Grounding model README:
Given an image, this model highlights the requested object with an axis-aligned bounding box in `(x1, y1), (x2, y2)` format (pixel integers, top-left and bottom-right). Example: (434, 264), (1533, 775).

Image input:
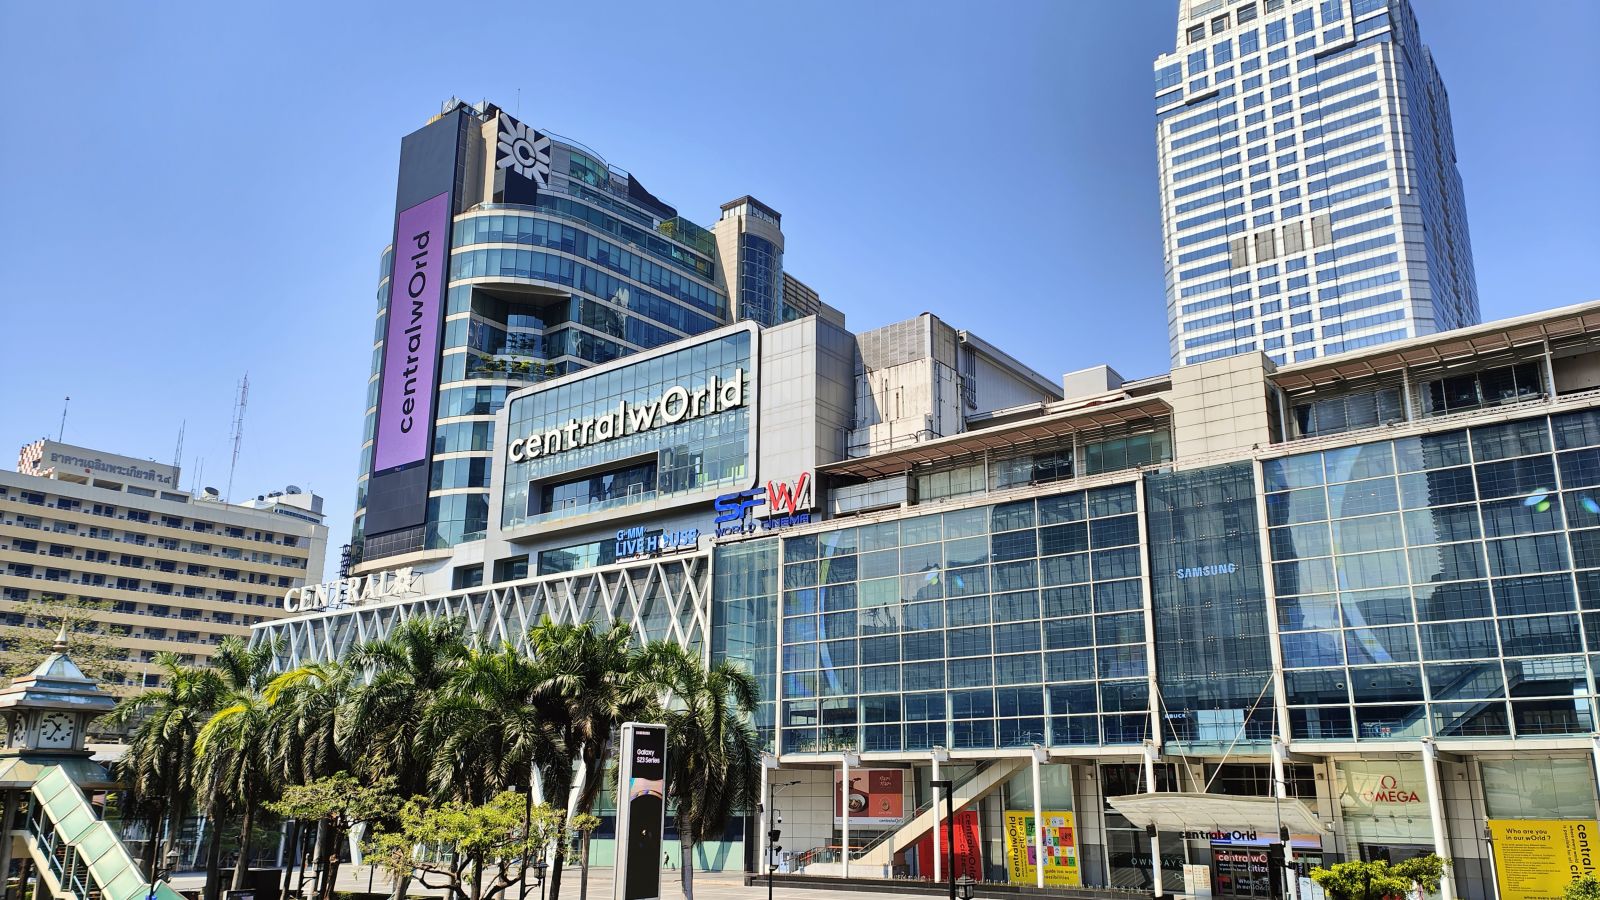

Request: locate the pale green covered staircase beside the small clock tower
(22, 765), (182, 900)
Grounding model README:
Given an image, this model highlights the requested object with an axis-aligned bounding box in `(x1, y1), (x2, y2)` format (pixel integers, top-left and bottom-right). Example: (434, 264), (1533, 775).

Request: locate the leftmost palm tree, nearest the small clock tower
(106, 653), (227, 881)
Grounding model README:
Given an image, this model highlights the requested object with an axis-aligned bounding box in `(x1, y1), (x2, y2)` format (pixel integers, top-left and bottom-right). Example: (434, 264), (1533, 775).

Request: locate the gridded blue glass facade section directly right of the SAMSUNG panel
(1264, 412), (1600, 741)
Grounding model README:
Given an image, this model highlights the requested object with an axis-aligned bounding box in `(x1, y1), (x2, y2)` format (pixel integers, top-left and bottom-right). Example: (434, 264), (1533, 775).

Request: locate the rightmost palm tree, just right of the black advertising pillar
(646, 641), (762, 900)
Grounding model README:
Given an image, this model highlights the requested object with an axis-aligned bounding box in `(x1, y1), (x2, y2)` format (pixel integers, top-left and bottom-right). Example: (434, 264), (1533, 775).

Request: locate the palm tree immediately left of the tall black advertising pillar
(528, 617), (658, 900)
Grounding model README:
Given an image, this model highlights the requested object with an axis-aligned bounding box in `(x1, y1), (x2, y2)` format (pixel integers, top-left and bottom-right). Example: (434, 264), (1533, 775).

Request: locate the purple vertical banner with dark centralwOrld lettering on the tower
(373, 191), (450, 472)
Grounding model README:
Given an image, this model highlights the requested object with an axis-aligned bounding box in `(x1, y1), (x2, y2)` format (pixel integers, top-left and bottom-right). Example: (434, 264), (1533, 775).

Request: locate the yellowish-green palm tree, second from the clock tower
(195, 637), (280, 897)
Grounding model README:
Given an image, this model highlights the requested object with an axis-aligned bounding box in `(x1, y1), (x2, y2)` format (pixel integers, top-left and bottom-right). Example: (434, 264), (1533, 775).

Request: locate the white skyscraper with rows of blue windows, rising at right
(1155, 0), (1478, 365)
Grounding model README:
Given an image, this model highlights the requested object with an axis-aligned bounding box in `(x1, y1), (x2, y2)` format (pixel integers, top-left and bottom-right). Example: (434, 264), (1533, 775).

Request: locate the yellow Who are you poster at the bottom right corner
(1490, 818), (1600, 900)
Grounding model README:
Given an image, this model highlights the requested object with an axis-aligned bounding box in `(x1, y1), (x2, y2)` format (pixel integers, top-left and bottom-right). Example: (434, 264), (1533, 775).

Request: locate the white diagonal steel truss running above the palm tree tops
(250, 552), (712, 669)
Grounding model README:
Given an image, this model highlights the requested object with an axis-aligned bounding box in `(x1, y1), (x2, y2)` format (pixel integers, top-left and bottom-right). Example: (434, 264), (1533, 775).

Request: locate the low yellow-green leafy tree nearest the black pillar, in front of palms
(363, 791), (565, 900)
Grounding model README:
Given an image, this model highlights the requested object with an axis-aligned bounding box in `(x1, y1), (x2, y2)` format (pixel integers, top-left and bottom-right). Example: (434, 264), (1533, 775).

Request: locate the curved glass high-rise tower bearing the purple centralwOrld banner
(352, 99), (816, 572)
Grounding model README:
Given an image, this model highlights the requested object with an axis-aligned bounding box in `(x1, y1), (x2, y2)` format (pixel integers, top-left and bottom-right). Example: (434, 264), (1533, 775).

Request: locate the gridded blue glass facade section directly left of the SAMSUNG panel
(779, 484), (1150, 753)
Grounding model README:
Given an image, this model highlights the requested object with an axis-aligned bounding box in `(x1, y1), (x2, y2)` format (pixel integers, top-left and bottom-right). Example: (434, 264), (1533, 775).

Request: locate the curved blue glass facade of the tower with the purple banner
(352, 126), (731, 560)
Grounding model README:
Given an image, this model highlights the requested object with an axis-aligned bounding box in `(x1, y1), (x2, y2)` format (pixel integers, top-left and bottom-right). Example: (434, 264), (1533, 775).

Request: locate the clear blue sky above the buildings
(0, 0), (1600, 573)
